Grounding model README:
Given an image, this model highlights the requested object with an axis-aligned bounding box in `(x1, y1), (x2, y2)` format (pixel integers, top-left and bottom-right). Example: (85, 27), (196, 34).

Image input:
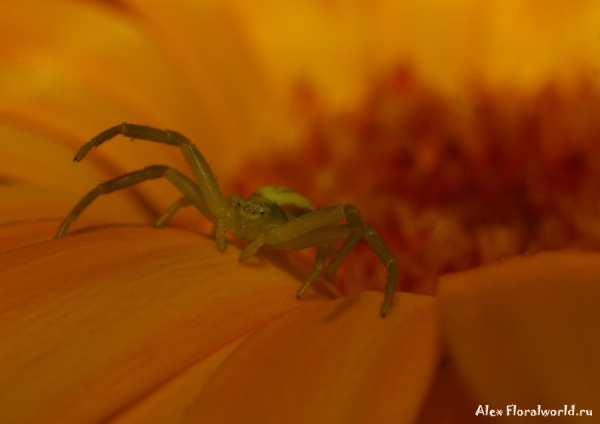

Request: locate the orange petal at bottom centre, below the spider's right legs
(186, 292), (440, 423)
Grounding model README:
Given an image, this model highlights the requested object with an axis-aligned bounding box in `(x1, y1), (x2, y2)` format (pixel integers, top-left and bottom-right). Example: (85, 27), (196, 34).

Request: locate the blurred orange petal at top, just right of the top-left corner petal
(110, 0), (297, 175)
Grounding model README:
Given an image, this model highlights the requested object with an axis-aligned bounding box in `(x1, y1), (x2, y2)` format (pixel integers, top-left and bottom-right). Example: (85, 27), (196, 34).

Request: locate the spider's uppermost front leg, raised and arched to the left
(73, 122), (226, 251)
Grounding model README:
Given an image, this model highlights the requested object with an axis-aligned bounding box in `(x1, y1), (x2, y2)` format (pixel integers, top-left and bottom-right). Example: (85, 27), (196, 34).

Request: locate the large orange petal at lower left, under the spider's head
(0, 227), (332, 423)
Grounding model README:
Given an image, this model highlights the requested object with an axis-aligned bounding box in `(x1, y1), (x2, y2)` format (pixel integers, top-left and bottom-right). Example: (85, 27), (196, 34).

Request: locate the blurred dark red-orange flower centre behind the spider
(230, 69), (600, 294)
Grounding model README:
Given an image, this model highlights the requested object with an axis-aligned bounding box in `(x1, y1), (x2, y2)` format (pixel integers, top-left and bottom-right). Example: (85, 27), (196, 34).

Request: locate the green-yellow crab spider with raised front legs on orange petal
(55, 123), (398, 317)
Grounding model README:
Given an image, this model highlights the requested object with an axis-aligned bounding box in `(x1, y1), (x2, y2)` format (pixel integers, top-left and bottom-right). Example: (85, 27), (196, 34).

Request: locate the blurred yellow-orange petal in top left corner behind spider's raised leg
(0, 0), (222, 209)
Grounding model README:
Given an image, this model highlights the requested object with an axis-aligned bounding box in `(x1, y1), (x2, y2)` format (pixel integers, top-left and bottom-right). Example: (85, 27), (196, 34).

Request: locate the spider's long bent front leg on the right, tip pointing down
(273, 205), (398, 316)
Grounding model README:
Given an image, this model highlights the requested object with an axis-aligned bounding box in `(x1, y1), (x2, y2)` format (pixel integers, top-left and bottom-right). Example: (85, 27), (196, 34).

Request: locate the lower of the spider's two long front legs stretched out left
(55, 165), (215, 238)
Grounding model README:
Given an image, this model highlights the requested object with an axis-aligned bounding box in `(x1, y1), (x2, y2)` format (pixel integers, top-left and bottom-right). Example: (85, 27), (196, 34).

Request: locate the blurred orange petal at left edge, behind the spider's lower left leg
(0, 121), (157, 232)
